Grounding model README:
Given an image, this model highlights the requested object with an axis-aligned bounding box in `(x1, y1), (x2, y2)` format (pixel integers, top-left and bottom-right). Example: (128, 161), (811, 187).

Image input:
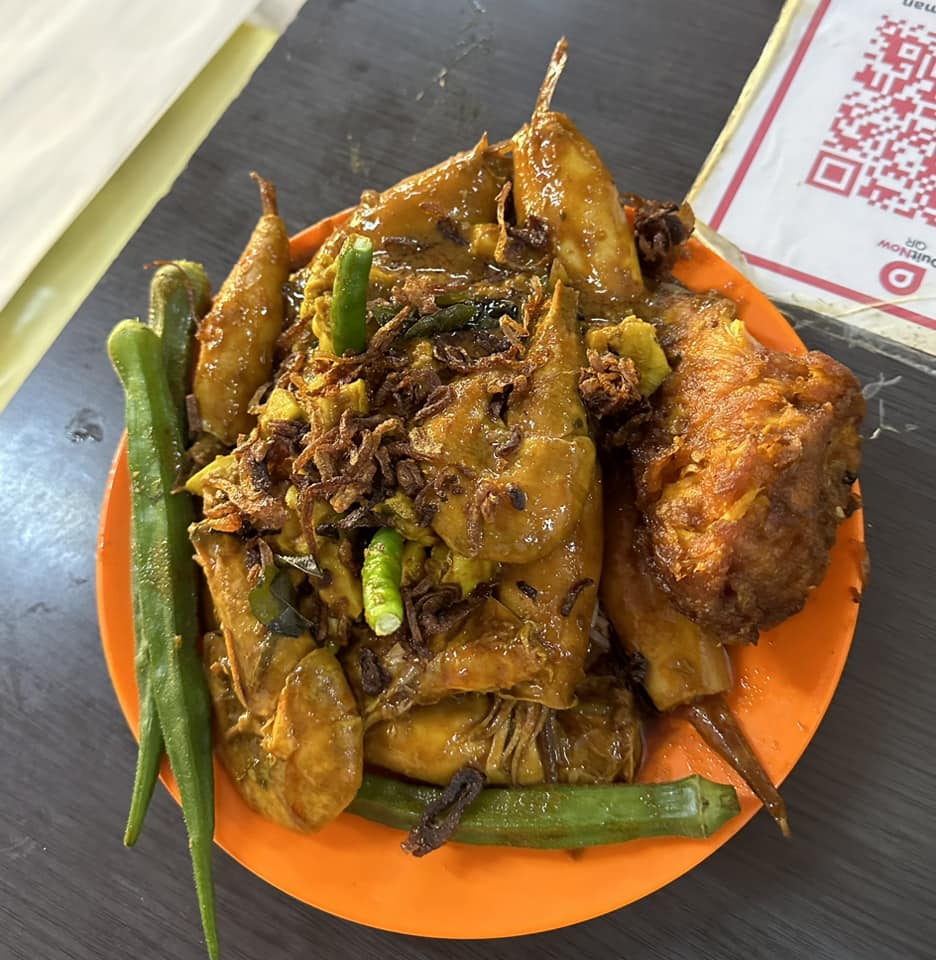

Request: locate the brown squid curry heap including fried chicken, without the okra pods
(179, 44), (863, 839)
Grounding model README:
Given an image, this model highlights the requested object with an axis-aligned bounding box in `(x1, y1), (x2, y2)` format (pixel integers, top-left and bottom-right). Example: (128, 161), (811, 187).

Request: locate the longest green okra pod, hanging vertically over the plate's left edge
(107, 320), (218, 958)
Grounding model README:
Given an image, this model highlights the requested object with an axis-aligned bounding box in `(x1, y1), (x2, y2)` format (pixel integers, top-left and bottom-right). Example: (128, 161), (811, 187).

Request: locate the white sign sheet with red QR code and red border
(690, 0), (936, 353)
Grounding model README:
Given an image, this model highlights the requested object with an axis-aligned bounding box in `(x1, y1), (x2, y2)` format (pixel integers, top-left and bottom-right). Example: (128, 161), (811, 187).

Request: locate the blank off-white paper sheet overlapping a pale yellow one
(0, 0), (256, 308)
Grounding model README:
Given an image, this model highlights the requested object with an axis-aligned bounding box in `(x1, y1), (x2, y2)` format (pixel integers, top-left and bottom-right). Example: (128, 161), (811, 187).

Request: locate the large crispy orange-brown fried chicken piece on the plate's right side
(633, 292), (864, 641)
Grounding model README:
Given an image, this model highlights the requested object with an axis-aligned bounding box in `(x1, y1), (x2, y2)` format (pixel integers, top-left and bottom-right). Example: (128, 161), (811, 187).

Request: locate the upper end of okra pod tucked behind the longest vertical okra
(149, 260), (211, 428)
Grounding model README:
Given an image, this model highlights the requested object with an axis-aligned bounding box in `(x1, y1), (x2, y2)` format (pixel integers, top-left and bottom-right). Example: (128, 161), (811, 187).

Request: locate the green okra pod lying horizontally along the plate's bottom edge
(348, 774), (740, 850)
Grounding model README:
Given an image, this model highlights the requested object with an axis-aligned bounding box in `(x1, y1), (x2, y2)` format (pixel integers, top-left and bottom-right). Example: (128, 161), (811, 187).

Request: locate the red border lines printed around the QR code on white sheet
(711, 0), (936, 330)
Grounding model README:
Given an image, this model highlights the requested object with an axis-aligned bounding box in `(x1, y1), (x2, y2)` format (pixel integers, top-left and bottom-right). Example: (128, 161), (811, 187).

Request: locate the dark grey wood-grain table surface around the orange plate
(0, 0), (936, 960)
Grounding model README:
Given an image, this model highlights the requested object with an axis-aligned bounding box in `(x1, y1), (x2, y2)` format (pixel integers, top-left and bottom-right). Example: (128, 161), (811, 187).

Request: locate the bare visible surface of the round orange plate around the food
(97, 214), (864, 938)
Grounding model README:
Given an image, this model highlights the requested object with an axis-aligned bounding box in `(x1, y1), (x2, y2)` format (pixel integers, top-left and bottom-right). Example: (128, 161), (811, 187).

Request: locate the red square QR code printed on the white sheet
(806, 16), (936, 226)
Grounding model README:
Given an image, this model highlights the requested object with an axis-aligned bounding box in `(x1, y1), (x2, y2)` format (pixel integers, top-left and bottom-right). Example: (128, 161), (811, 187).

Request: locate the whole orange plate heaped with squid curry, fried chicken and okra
(98, 41), (865, 956)
